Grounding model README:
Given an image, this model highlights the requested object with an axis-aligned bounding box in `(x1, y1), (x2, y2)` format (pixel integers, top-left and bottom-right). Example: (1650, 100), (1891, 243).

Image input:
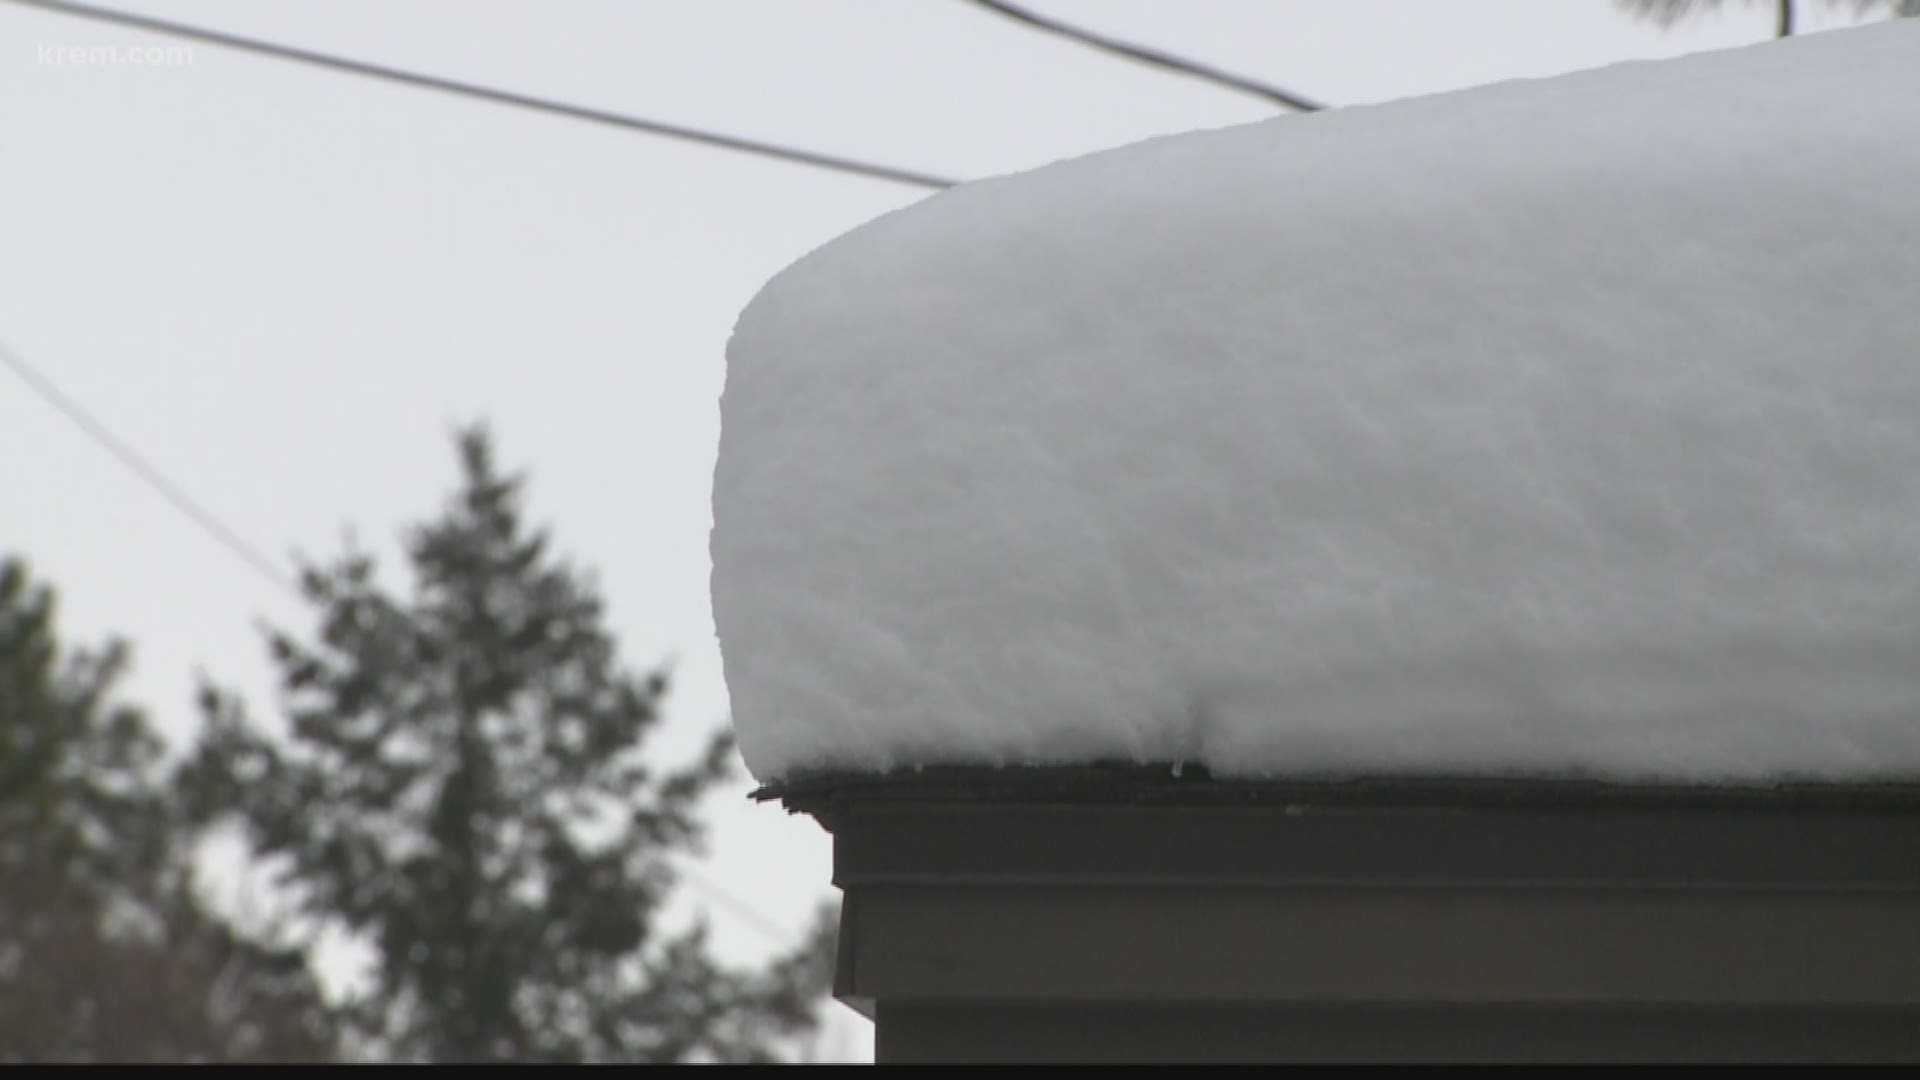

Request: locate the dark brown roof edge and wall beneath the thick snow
(762, 769), (1920, 1063)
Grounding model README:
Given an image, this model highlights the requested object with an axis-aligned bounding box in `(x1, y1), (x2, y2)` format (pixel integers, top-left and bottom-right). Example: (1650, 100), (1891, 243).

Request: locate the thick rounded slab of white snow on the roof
(710, 21), (1920, 782)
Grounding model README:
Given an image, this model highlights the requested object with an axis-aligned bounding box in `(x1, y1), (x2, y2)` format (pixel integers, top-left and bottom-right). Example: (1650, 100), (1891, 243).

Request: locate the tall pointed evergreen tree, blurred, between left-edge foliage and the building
(190, 429), (828, 1063)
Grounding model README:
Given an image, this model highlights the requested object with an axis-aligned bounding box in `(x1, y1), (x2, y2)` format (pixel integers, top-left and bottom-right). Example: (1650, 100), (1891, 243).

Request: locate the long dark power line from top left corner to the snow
(6, 0), (958, 188)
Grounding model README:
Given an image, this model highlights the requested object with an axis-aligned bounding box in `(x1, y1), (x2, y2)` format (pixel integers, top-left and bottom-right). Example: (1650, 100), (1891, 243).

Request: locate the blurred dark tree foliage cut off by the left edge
(0, 559), (332, 1063)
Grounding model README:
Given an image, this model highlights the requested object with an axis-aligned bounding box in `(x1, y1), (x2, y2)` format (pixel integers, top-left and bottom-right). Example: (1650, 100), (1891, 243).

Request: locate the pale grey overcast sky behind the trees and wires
(0, 0), (1889, 1059)
